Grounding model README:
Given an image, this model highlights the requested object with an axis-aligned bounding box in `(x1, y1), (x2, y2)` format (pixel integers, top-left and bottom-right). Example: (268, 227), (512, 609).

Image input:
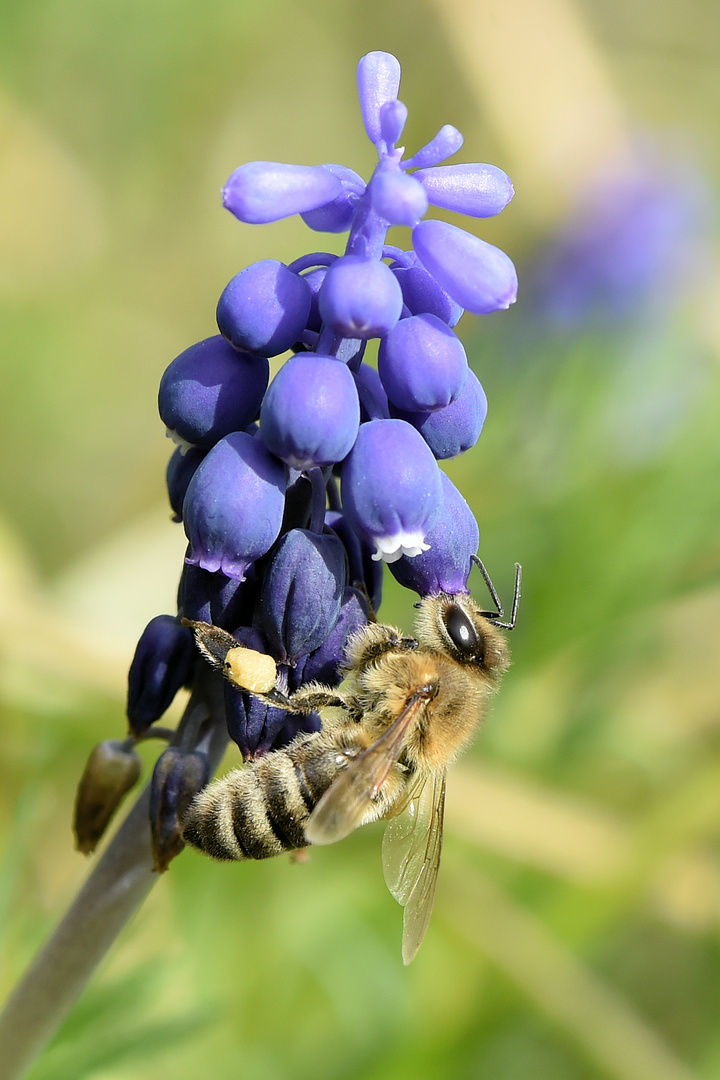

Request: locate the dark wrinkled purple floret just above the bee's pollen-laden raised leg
(259, 529), (348, 666)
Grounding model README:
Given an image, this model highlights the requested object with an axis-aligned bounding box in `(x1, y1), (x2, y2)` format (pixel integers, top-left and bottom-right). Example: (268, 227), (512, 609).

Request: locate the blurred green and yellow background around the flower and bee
(0, 0), (720, 1080)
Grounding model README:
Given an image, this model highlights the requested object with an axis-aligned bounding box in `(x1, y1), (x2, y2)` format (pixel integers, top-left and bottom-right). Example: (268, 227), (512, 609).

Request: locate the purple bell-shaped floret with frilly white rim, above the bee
(342, 420), (443, 563)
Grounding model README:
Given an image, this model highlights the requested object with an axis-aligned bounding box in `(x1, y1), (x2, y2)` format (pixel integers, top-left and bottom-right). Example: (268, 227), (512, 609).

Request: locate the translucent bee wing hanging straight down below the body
(382, 772), (445, 963)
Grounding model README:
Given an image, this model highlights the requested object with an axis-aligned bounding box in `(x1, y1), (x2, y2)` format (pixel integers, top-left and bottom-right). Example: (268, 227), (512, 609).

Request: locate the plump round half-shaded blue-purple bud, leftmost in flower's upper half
(158, 334), (270, 449)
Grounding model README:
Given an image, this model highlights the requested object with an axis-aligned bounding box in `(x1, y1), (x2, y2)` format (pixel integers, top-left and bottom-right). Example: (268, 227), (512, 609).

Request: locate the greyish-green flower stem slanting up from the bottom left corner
(0, 665), (228, 1080)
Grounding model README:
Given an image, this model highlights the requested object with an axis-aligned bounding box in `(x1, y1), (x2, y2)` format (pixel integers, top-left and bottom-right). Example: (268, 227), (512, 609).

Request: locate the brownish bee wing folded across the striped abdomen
(305, 693), (426, 843)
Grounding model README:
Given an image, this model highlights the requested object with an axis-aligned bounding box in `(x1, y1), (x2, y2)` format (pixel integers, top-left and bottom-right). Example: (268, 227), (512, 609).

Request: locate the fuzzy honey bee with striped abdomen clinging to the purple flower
(182, 558), (520, 963)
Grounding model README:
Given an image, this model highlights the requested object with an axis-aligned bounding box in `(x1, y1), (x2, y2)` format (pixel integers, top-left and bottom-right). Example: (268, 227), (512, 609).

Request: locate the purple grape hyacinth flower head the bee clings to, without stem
(78, 52), (517, 869)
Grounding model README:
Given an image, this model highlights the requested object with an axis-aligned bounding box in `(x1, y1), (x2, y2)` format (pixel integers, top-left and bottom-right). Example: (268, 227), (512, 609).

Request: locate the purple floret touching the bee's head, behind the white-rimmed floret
(390, 473), (480, 596)
